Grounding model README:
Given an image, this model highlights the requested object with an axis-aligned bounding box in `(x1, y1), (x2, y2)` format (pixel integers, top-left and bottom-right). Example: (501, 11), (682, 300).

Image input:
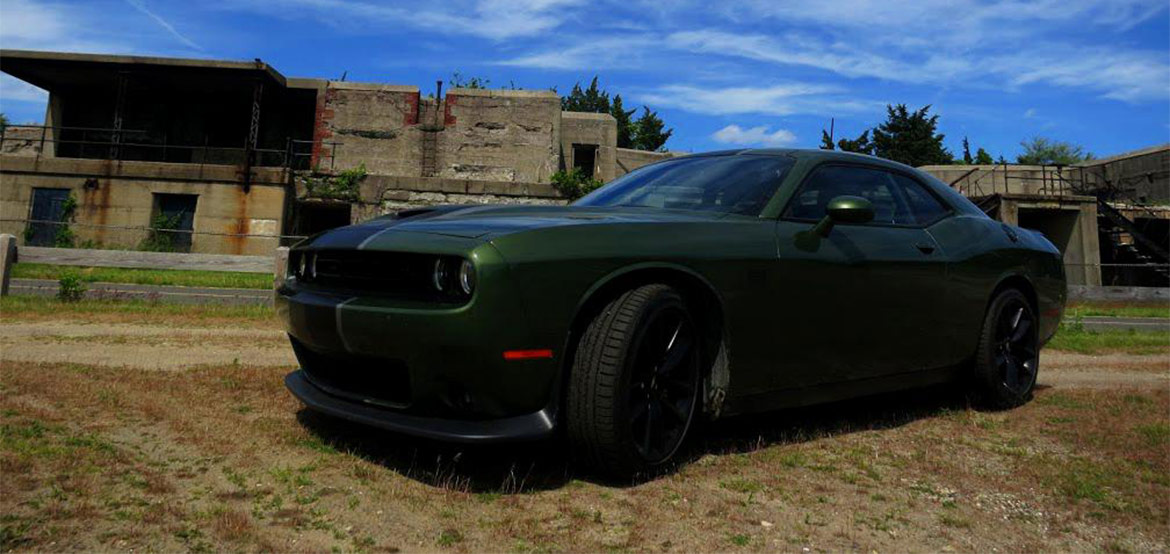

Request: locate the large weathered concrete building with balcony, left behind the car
(0, 50), (670, 254)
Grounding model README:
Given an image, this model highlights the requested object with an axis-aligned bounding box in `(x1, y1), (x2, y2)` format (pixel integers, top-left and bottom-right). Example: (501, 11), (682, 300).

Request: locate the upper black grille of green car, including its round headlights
(289, 250), (461, 303)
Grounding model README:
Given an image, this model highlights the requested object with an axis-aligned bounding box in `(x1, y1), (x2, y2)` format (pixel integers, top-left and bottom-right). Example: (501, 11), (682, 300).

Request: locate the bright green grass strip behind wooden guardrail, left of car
(12, 263), (273, 289)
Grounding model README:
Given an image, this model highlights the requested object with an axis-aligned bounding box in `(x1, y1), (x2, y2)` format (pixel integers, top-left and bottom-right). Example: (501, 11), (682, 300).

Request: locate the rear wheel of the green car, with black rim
(972, 289), (1040, 409)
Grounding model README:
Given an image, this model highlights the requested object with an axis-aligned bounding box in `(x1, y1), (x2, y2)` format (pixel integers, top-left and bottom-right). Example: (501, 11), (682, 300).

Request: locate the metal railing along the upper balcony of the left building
(0, 125), (339, 169)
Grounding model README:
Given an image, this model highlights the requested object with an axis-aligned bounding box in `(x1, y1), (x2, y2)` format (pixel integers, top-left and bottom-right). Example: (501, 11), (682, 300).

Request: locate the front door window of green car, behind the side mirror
(784, 166), (915, 224)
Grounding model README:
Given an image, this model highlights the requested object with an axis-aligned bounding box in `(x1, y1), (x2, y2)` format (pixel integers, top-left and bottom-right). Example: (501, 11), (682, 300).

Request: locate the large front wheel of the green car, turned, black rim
(566, 284), (702, 477)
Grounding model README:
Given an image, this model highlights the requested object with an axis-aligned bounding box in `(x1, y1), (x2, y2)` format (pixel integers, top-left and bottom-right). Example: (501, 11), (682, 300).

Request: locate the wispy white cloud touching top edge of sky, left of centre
(226, 0), (585, 40)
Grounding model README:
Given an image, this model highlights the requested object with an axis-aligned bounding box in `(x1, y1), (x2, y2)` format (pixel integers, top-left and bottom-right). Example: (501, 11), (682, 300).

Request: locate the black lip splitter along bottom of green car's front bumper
(284, 369), (553, 443)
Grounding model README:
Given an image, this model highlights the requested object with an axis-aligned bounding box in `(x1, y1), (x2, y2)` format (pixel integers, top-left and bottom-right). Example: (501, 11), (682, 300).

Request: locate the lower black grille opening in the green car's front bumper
(291, 339), (411, 408)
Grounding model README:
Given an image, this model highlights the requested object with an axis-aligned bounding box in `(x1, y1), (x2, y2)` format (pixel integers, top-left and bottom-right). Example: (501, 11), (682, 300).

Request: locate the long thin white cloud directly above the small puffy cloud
(636, 83), (885, 116)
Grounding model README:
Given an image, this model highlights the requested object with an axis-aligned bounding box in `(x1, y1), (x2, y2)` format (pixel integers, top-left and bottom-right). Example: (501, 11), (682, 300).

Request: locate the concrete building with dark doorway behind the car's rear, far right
(921, 145), (1170, 286)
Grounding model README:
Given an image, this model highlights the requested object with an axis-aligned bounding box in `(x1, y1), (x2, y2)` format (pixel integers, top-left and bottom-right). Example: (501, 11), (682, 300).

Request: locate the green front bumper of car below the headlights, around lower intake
(275, 240), (560, 434)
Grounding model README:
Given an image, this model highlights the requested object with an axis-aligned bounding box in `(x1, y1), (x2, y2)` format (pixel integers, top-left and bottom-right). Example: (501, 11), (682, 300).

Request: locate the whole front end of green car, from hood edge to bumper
(276, 213), (559, 442)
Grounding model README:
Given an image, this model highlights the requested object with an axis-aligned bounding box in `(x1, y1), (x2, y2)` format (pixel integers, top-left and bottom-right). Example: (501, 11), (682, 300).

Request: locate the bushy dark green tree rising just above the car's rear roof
(873, 104), (952, 167)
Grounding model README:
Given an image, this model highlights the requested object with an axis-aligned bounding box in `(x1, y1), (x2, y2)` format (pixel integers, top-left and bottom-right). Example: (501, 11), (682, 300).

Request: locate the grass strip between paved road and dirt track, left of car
(0, 296), (275, 320)
